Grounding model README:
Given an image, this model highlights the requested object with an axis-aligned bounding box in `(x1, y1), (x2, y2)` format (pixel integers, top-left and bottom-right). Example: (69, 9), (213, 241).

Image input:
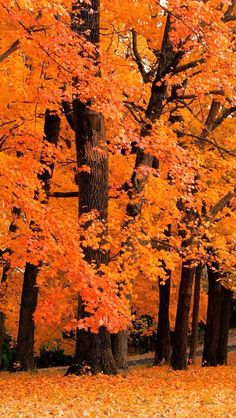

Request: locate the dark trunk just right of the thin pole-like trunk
(202, 267), (221, 366)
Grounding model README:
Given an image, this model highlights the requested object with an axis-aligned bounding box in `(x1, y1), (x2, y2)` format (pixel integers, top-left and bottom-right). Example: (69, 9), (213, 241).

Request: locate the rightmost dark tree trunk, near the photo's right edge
(217, 286), (233, 365)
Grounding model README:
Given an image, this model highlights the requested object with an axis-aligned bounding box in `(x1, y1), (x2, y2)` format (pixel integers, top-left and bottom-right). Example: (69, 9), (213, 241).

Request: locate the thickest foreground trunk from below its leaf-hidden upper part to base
(71, 99), (117, 374)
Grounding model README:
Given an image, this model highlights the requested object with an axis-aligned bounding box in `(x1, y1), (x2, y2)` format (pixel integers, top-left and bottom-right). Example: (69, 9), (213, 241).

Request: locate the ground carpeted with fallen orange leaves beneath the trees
(0, 354), (236, 418)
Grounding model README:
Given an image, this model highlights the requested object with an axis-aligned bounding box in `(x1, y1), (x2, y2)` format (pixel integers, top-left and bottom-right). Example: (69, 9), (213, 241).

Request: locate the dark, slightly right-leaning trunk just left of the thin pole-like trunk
(171, 264), (195, 370)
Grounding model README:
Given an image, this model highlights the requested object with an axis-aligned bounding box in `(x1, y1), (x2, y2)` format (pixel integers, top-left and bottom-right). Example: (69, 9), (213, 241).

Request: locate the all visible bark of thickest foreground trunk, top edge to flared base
(66, 0), (117, 374)
